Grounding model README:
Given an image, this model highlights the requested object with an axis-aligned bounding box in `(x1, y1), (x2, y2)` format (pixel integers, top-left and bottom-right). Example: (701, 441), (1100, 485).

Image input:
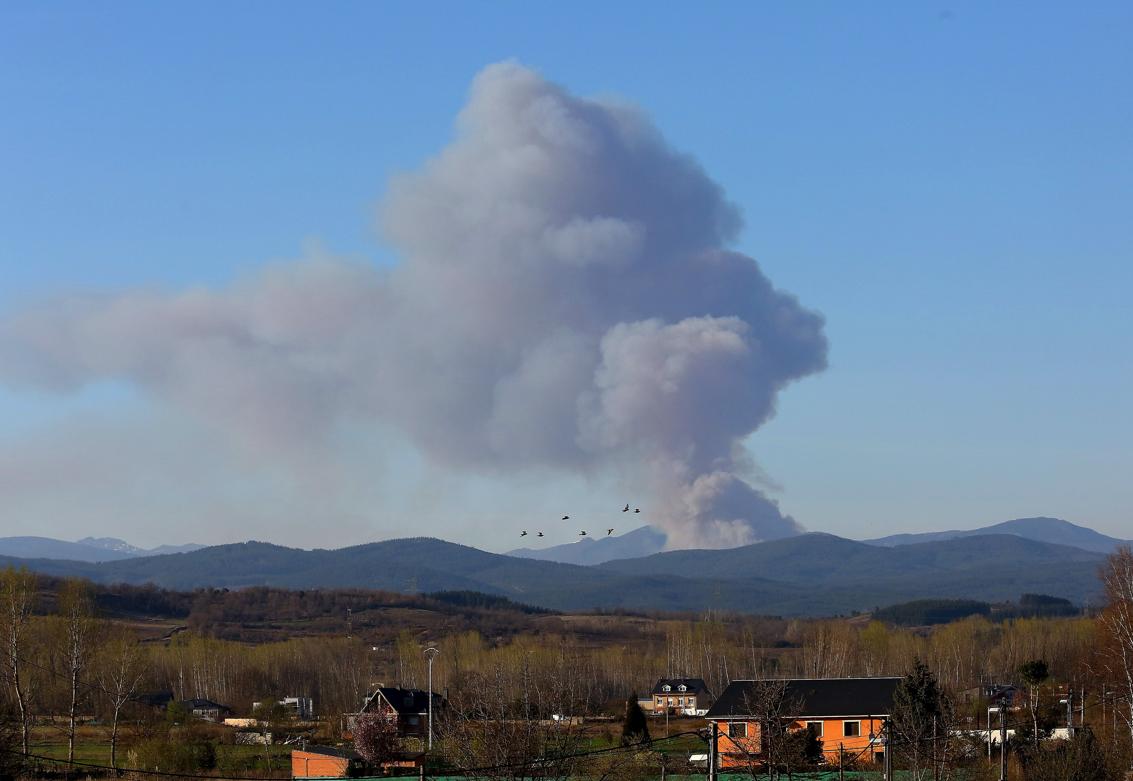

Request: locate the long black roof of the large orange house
(705, 678), (901, 719)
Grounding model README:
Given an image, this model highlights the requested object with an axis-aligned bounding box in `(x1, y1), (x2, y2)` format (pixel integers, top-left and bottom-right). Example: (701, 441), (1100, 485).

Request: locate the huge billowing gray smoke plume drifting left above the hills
(0, 63), (826, 546)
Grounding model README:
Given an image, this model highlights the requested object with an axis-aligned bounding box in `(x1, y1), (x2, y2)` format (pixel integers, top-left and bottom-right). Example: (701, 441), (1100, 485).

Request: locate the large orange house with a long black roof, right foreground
(705, 678), (901, 769)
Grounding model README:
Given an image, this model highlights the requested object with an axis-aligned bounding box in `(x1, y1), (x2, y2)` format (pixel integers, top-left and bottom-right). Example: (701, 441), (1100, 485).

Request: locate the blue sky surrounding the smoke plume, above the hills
(0, 2), (1133, 550)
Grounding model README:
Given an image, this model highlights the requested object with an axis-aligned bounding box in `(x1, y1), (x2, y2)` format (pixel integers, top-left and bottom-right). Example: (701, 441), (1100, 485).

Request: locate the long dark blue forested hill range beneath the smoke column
(0, 519), (1105, 616)
